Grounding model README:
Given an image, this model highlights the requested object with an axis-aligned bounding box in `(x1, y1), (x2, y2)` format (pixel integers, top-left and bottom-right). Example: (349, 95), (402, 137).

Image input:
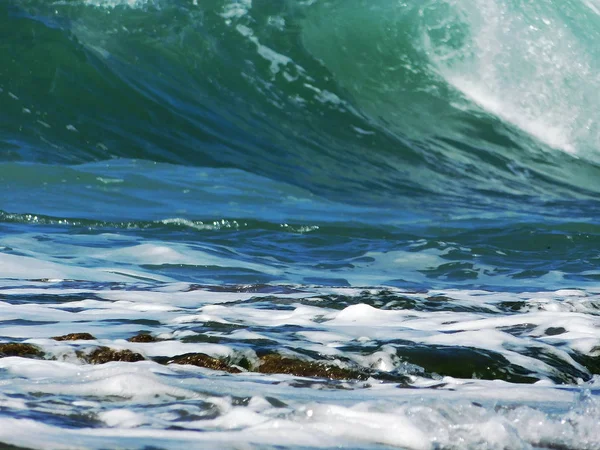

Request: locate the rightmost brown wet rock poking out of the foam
(258, 354), (367, 380)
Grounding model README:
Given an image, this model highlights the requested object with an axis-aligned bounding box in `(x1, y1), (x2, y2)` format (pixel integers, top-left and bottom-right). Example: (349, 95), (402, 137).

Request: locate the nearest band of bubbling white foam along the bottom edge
(0, 390), (599, 449)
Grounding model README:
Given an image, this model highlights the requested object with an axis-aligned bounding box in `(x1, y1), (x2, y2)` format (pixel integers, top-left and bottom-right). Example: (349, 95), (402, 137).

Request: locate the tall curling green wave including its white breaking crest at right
(0, 0), (600, 209)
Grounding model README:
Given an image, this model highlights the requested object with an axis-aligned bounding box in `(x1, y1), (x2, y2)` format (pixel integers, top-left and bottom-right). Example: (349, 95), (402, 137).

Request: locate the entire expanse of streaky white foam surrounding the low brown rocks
(0, 282), (600, 449)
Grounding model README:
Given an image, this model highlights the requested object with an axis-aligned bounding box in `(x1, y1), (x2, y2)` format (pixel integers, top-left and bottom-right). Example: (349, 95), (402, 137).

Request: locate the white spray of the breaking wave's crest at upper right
(423, 0), (600, 157)
